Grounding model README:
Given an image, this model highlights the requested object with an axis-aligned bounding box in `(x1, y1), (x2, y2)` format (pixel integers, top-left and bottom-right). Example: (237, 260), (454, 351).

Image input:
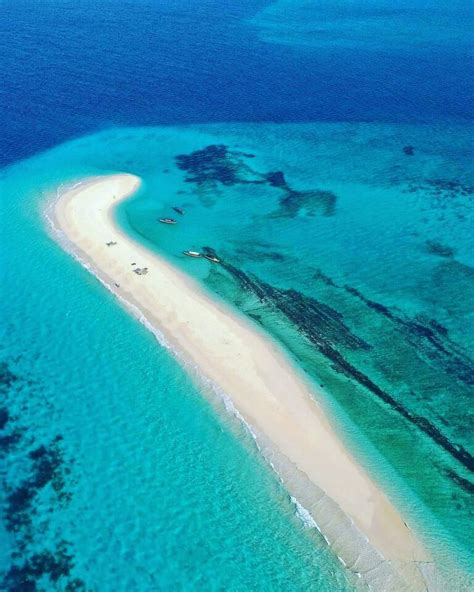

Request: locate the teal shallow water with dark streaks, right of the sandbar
(116, 124), (474, 571)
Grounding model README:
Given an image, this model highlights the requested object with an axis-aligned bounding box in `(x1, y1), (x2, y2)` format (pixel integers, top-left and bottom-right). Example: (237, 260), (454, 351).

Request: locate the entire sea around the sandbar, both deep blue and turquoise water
(0, 0), (474, 592)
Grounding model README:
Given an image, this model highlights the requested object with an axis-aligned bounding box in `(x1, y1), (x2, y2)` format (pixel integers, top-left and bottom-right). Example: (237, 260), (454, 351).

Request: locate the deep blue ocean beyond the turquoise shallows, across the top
(0, 0), (473, 163)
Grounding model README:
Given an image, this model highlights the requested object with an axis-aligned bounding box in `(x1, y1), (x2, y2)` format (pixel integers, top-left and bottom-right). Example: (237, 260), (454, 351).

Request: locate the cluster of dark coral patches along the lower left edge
(0, 361), (81, 592)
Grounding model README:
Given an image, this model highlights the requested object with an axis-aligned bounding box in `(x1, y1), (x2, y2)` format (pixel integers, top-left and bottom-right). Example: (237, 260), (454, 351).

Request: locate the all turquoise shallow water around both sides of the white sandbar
(2, 119), (474, 591)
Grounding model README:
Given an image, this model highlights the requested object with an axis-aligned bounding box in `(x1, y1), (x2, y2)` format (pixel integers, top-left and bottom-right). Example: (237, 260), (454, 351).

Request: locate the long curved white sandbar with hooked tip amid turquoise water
(51, 174), (436, 592)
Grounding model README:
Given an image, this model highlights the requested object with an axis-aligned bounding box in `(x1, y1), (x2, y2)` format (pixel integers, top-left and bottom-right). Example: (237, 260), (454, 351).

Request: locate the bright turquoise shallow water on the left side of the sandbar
(0, 138), (362, 591)
